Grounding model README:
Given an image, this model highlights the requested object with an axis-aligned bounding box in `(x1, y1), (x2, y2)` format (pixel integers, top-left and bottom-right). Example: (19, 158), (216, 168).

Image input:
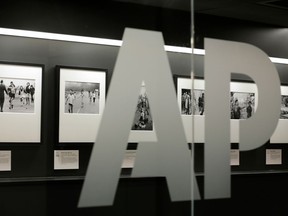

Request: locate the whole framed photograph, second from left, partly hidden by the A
(56, 66), (107, 143)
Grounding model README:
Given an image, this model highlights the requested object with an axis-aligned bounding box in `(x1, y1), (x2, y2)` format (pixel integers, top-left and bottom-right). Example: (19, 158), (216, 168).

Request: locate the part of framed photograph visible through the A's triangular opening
(128, 81), (157, 143)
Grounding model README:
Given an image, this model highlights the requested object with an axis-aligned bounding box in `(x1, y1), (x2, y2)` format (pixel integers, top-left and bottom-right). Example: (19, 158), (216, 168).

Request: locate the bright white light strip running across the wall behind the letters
(0, 28), (288, 64)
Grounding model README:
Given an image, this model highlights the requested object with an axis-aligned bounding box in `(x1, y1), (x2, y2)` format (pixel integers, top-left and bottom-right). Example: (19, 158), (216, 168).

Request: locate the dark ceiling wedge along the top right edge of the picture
(114, 0), (288, 27)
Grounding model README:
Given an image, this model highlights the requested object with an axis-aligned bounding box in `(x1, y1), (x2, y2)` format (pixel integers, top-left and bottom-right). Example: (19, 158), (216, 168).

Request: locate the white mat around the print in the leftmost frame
(0, 62), (44, 143)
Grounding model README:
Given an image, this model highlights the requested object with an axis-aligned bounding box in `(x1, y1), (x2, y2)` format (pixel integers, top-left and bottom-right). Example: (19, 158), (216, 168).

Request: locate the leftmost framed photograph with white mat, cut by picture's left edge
(0, 62), (44, 143)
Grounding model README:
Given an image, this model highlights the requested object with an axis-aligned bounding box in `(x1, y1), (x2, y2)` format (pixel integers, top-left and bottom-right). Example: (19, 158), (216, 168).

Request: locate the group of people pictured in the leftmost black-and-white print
(0, 80), (35, 112)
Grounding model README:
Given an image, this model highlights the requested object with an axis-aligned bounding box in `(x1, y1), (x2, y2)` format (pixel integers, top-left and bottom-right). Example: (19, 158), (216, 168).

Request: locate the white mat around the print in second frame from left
(58, 66), (106, 143)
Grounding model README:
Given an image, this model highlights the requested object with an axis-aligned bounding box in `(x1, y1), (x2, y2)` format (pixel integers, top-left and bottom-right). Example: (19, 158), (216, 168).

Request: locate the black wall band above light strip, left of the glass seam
(0, 0), (190, 46)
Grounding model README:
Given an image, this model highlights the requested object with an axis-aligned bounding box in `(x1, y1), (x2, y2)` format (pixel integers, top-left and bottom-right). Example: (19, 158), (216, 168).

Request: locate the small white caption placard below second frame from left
(54, 150), (79, 170)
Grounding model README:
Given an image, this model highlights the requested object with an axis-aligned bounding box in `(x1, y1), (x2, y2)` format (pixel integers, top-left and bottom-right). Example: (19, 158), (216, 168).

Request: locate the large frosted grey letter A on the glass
(78, 29), (200, 207)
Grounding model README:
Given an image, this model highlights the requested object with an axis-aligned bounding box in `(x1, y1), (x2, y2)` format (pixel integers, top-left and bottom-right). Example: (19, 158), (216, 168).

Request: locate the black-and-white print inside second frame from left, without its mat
(65, 81), (100, 114)
